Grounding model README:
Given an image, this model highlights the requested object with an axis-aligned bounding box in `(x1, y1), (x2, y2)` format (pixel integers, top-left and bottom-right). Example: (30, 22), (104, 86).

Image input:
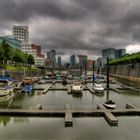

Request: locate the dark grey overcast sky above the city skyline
(0, 0), (140, 59)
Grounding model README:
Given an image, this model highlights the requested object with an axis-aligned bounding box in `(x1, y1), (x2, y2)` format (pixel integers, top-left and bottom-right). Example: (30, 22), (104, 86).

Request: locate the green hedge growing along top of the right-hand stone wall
(110, 52), (140, 65)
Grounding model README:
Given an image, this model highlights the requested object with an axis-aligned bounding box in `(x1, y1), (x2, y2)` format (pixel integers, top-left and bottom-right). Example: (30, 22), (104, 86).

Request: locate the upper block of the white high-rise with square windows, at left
(12, 26), (29, 42)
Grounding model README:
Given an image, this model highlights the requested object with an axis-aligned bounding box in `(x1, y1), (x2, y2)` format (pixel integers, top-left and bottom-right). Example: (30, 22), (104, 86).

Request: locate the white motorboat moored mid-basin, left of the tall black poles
(71, 81), (83, 93)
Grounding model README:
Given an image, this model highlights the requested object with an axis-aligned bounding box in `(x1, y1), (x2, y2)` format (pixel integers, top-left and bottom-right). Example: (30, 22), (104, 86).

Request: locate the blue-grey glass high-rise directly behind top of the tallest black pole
(102, 48), (115, 64)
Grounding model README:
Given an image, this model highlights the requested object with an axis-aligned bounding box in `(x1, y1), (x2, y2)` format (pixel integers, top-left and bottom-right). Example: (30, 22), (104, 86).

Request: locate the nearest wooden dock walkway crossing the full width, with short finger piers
(0, 103), (140, 126)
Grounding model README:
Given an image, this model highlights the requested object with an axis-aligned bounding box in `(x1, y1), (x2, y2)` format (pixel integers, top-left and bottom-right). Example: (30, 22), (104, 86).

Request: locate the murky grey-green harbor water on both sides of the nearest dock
(0, 84), (140, 140)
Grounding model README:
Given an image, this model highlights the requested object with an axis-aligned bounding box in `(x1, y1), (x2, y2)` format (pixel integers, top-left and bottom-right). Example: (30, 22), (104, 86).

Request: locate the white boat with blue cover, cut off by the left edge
(0, 78), (15, 96)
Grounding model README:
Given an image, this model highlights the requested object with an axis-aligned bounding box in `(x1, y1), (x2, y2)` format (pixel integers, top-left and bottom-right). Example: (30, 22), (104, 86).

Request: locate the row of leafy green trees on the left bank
(0, 41), (35, 66)
